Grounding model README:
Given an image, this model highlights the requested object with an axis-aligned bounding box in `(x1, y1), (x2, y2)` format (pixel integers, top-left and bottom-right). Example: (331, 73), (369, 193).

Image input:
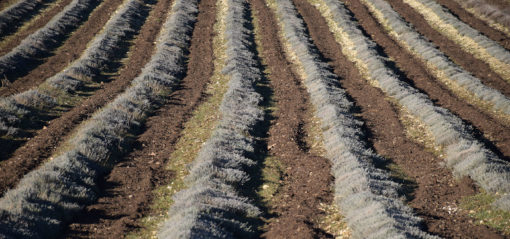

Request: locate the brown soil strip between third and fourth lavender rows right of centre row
(387, 0), (510, 97)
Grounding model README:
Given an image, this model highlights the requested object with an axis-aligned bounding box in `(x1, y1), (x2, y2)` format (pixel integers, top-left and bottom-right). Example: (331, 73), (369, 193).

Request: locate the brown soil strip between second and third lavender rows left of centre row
(0, 0), (123, 96)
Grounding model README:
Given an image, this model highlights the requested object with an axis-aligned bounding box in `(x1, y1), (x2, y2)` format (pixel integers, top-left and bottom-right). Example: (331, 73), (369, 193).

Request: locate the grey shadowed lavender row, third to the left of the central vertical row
(0, 0), (100, 82)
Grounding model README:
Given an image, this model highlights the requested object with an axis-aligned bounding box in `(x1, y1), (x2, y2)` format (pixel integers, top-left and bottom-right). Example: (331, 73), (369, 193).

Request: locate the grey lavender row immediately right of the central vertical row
(275, 0), (433, 238)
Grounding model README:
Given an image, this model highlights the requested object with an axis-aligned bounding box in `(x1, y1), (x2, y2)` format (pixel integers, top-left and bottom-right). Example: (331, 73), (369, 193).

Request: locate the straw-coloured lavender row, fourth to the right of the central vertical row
(403, 0), (510, 82)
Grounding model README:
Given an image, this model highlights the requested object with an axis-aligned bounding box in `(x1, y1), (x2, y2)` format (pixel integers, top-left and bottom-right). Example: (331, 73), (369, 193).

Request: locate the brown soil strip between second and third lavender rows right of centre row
(346, 0), (510, 164)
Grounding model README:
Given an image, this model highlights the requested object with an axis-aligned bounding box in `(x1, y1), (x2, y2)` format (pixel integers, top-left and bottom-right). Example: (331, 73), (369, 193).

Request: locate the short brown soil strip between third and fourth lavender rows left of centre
(0, 0), (72, 56)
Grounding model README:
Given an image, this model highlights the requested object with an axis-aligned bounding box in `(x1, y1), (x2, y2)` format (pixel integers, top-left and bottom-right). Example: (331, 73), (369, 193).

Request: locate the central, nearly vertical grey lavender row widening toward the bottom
(158, 0), (263, 238)
